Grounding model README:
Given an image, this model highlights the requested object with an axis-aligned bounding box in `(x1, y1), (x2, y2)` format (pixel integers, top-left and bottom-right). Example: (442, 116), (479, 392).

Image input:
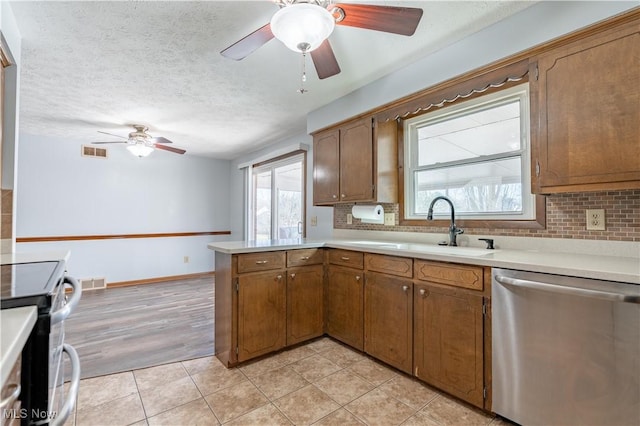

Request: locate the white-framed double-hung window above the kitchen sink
(404, 84), (536, 220)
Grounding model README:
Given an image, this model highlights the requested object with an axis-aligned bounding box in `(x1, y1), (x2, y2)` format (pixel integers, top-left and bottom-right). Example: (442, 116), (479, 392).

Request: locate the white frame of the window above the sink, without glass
(403, 83), (536, 221)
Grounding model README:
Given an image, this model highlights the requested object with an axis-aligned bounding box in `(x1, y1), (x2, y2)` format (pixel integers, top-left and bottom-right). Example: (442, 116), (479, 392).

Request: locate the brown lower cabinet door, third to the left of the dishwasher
(326, 266), (364, 351)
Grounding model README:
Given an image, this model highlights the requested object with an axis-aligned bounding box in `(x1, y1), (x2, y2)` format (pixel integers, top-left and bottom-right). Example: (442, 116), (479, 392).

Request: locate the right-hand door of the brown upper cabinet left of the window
(340, 117), (374, 201)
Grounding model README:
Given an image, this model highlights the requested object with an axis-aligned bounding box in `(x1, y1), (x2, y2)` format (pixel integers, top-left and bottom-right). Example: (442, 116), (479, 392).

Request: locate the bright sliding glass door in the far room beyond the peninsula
(249, 153), (305, 240)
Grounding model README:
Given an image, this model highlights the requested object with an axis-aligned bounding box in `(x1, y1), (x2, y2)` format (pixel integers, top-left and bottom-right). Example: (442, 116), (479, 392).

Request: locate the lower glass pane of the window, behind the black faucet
(414, 156), (523, 215)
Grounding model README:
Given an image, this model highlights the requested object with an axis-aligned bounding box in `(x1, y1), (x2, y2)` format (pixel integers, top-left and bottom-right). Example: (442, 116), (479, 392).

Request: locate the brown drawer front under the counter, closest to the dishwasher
(414, 260), (484, 290)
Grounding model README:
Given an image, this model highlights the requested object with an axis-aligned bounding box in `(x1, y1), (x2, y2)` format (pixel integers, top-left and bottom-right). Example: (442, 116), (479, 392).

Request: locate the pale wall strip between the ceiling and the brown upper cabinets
(307, 0), (640, 133)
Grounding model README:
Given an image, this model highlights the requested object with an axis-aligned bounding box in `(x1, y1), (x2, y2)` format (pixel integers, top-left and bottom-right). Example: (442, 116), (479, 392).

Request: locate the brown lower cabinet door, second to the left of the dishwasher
(364, 273), (413, 374)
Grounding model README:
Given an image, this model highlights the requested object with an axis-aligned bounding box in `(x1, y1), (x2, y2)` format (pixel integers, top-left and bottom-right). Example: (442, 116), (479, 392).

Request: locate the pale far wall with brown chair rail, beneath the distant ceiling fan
(16, 134), (235, 282)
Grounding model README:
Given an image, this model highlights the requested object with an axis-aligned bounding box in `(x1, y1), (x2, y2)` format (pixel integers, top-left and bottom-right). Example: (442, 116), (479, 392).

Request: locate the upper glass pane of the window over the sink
(417, 100), (521, 167)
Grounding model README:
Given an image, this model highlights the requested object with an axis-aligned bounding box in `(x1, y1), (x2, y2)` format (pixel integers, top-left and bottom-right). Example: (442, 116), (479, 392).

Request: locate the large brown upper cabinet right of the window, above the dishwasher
(530, 19), (640, 194)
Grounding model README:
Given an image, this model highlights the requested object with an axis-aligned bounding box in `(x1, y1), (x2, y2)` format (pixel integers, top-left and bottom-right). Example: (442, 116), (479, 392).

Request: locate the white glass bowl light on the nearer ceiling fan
(271, 3), (335, 53)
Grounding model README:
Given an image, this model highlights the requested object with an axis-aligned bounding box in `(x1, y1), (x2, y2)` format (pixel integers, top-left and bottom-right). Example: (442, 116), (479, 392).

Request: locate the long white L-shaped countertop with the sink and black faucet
(207, 239), (640, 284)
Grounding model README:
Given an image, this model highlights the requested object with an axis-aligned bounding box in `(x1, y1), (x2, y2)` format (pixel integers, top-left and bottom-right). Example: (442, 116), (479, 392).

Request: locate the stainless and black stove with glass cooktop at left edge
(0, 261), (82, 425)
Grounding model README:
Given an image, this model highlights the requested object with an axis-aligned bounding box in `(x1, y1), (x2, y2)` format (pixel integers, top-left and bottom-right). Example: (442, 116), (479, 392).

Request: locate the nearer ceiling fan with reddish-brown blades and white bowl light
(220, 0), (422, 81)
